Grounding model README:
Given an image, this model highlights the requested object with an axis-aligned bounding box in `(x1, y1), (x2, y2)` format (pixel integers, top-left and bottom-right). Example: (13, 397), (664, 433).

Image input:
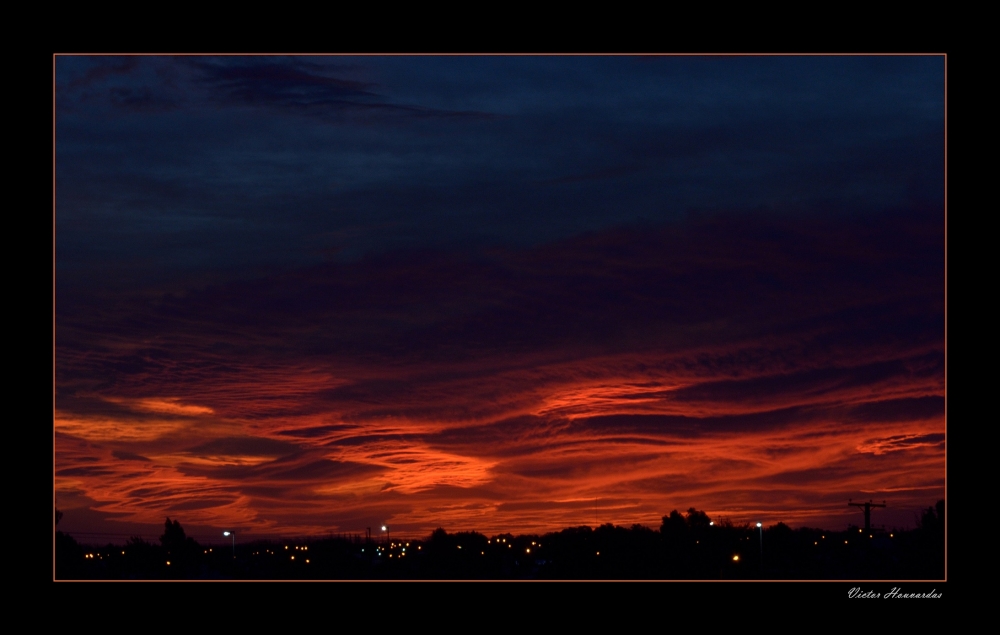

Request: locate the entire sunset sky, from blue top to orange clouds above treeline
(54, 56), (945, 539)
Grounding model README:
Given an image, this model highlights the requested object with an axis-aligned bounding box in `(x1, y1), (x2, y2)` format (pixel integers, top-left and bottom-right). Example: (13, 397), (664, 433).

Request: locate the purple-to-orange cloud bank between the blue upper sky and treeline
(55, 215), (945, 536)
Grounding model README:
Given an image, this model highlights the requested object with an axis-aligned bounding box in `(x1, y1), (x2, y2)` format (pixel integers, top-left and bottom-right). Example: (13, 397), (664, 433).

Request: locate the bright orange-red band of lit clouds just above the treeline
(56, 338), (943, 535)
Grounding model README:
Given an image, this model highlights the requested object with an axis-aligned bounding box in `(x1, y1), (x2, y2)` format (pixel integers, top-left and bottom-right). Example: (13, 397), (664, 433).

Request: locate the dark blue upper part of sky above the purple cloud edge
(56, 56), (943, 304)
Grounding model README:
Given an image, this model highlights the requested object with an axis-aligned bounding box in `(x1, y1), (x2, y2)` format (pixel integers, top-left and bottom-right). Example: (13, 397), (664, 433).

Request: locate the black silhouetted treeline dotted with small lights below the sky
(56, 501), (945, 580)
